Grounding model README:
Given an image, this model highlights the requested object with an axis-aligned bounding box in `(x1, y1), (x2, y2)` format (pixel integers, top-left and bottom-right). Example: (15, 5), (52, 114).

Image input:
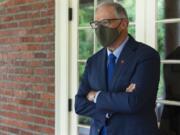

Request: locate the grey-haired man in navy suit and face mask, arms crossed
(75, 2), (160, 135)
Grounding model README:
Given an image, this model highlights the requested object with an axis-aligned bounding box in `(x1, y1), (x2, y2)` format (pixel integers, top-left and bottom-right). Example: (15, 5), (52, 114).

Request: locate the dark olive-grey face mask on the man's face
(95, 25), (120, 47)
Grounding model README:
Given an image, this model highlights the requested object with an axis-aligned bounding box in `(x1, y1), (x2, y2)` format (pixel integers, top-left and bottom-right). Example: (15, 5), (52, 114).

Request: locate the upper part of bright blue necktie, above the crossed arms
(107, 53), (116, 89)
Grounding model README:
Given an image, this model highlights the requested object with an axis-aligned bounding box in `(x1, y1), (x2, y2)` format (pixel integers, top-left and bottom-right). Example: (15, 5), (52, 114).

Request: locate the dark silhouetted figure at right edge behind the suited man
(160, 46), (180, 135)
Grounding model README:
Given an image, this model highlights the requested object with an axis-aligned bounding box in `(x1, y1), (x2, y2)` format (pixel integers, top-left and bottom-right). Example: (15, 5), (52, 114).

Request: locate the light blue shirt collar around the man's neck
(107, 36), (129, 62)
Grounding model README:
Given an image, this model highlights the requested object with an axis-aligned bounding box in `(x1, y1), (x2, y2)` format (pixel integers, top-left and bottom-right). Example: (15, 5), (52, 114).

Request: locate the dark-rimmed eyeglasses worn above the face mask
(90, 18), (124, 29)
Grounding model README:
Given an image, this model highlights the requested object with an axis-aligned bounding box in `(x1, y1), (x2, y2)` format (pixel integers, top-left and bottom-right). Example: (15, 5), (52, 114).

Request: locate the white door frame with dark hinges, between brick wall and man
(55, 0), (78, 135)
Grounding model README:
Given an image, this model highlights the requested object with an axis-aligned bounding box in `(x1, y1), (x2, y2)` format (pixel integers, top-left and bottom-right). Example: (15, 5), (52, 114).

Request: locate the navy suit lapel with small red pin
(110, 37), (136, 90)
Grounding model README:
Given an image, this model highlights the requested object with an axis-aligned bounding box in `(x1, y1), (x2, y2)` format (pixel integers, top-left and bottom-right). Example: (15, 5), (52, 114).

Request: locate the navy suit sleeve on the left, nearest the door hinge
(75, 61), (105, 118)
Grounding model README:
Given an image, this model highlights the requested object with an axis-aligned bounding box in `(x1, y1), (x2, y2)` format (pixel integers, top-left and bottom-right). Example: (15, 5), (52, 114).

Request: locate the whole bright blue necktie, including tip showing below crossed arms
(101, 53), (116, 135)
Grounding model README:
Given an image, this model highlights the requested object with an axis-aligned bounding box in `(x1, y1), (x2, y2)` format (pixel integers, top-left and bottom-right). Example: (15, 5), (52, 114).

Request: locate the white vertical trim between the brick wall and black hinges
(55, 0), (69, 135)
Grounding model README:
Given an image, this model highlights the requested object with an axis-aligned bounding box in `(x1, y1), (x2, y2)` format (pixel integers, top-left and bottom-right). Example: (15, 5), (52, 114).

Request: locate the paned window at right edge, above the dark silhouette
(156, 0), (180, 96)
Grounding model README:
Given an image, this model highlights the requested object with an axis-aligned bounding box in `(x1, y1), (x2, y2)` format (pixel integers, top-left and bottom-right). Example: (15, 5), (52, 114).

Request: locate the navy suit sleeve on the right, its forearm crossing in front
(96, 53), (160, 113)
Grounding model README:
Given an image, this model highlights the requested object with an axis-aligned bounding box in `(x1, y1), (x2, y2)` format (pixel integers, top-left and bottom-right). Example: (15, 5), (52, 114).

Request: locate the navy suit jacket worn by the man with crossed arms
(75, 35), (160, 135)
